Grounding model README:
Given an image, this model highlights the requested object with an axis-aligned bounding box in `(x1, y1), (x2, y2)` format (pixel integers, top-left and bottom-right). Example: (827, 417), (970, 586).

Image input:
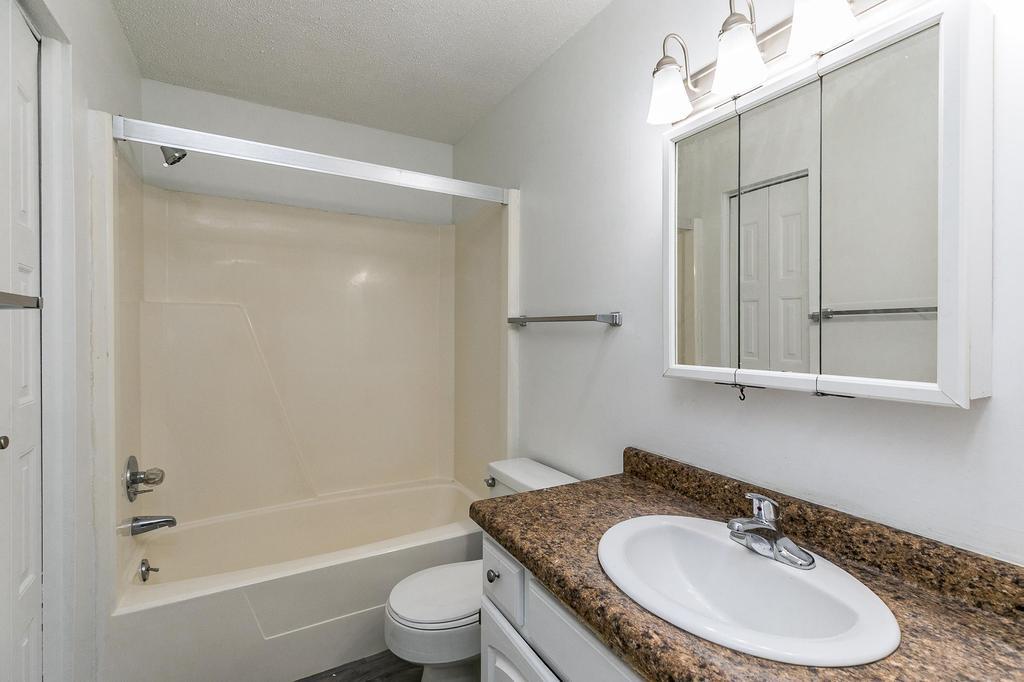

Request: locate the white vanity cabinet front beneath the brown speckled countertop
(480, 536), (641, 682)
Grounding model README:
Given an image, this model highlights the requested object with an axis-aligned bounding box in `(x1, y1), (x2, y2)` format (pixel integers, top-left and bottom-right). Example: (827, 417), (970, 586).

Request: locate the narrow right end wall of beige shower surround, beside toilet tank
(455, 206), (509, 497)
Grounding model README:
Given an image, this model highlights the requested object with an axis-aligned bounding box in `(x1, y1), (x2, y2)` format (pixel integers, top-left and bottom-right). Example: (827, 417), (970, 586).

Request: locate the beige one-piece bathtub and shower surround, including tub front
(97, 134), (508, 680)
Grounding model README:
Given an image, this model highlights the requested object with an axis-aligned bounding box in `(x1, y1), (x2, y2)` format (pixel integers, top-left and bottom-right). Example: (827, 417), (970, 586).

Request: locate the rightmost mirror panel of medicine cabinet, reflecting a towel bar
(818, 27), (939, 382)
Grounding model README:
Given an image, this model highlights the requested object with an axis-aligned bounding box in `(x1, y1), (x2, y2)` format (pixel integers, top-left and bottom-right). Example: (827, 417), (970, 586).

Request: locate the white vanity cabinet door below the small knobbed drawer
(480, 597), (558, 682)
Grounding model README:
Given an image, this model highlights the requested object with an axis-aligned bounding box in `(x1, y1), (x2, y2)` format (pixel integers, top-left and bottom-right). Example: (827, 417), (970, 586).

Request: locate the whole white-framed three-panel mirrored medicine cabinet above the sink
(663, 1), (993, 408)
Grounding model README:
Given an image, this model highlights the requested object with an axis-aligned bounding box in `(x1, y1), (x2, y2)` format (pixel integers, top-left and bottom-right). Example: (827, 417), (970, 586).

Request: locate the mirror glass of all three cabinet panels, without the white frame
(672, 27), (940, 383)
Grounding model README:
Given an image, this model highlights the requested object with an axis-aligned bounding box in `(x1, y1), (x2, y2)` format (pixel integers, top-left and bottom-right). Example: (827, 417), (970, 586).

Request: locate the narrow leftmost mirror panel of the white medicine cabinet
(675, 117), (739, 369)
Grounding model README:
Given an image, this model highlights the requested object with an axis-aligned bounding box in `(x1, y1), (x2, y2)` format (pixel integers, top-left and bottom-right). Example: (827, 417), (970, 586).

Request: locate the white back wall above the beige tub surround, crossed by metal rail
(141, 80), (453, 224)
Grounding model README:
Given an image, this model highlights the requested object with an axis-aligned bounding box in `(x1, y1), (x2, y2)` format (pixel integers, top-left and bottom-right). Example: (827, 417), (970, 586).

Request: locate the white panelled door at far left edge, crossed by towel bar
(0, 0), (42, 682)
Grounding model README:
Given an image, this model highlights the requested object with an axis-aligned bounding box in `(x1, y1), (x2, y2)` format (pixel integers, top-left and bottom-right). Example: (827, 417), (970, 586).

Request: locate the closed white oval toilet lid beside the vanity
(387, 560), (483, 629)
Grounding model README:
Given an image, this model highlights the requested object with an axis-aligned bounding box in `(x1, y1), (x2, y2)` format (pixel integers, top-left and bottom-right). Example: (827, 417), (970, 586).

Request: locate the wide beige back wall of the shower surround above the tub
(139, 185), (455, 521)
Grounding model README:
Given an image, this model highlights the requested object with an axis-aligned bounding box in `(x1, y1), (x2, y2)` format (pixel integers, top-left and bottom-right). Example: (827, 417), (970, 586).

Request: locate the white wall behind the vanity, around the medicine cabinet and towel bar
(456, 0), (1024, 563)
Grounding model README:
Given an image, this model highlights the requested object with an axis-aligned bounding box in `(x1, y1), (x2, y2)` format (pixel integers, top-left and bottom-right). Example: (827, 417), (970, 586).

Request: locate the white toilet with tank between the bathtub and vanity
(384, 458), (578, 682)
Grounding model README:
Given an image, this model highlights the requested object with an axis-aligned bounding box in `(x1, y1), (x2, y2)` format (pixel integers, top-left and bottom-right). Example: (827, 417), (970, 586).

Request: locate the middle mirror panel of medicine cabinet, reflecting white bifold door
(729, 81), (821, 374)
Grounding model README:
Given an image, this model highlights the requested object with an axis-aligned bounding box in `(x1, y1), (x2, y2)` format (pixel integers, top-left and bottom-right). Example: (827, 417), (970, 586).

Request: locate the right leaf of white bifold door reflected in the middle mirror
(768, 177), (811, 373)
